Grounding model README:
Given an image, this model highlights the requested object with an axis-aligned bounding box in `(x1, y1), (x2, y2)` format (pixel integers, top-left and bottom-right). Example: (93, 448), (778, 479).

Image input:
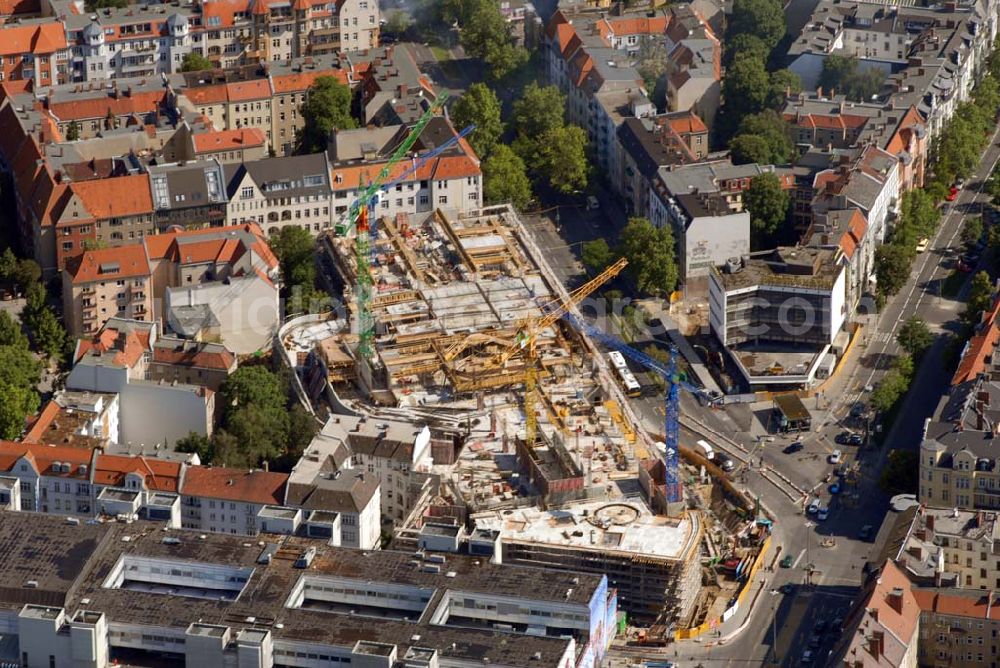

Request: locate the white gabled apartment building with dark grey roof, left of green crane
(225, 153), (333, 236)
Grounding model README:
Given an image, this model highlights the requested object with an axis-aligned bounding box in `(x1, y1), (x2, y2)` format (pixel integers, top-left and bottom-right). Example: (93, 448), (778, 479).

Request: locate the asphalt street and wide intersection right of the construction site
(525, 118), (1000, 666)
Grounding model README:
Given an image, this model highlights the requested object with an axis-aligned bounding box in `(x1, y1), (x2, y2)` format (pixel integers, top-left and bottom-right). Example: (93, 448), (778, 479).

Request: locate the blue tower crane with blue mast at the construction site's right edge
(563, 312), (717, 503)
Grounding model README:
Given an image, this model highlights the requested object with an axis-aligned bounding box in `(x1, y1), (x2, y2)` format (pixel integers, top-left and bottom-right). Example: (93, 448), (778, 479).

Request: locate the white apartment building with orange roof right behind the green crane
(327, 116), (483, 222)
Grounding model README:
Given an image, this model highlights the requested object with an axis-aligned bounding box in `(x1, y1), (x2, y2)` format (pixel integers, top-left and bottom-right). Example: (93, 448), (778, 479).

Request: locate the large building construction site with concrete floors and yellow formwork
(281, 206), (764, 629)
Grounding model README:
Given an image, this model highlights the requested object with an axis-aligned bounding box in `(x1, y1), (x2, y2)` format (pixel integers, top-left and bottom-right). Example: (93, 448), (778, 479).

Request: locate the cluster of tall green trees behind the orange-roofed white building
(451, 82), (590, 209)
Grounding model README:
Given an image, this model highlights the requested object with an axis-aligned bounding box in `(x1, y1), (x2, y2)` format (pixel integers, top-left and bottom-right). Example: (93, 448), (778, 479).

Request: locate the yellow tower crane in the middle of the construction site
(443, 258), (628, 448)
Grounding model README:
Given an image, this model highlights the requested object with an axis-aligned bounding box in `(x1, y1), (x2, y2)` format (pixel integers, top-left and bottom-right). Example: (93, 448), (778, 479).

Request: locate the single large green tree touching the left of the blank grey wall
(620, 218), (677, 295)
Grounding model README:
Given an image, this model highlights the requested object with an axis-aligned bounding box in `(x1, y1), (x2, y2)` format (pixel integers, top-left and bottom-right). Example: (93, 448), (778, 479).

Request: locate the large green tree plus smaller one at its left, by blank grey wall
(581, 218), (677, 295)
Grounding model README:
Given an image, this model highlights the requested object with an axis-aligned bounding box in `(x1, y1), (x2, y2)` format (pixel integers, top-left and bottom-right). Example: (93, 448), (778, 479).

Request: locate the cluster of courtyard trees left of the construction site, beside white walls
(176, 365), (319, 471)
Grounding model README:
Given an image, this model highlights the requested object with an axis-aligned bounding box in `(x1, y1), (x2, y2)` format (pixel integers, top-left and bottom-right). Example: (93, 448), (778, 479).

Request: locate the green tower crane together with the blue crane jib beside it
(335, 93), (472, 361)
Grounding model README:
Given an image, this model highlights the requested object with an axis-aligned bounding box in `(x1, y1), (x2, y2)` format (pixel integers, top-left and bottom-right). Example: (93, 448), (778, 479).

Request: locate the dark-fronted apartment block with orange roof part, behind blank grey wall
(612, 111), (708, 217)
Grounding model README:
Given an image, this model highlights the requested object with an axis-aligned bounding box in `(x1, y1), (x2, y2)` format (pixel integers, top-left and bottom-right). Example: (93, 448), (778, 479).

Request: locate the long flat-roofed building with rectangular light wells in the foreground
(0, 513), (600, 668)
